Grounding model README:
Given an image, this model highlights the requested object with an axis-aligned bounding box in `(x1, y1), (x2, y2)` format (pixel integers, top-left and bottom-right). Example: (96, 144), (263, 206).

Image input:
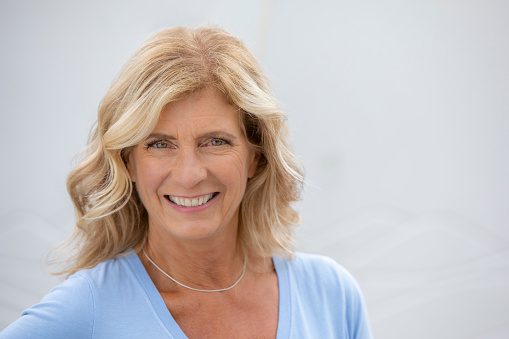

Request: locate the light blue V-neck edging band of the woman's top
(127, 252), (292, 339)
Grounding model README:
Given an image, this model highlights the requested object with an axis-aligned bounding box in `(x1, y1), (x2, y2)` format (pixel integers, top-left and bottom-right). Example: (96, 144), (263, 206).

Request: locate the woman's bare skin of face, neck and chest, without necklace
(128, 88), (278, 338)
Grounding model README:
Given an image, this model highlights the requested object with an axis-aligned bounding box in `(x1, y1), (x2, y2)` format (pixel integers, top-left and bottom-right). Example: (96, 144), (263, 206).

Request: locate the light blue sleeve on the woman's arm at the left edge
(0, 274), (94, 339)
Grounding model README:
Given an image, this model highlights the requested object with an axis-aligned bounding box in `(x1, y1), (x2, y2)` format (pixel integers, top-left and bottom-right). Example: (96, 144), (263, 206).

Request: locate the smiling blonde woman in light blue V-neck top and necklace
(1, 28), (371, 338)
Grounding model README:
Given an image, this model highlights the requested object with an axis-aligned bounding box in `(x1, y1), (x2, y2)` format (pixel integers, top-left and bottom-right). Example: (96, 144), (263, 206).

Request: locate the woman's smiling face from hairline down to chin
(128, 88), (257, 243)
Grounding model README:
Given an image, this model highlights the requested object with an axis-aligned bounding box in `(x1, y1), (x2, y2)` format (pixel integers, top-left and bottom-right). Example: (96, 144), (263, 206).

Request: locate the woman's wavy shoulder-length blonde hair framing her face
(60, 27), (303, 274)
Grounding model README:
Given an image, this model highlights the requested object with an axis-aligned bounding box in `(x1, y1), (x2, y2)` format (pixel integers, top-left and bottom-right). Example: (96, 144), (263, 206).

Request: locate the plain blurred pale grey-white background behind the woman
(0, 0), (509, 339)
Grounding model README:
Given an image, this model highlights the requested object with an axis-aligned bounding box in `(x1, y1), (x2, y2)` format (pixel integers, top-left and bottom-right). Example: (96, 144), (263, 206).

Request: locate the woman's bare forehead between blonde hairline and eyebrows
(155, 87), (241, 131)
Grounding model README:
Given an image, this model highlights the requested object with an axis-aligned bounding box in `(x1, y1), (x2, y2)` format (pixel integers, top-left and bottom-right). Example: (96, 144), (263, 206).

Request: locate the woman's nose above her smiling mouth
(172, 148), (207, 188)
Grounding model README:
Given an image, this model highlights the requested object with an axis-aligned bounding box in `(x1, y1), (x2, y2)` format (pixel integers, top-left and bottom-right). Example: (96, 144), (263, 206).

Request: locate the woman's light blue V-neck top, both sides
(0, 252), (372, 339)
